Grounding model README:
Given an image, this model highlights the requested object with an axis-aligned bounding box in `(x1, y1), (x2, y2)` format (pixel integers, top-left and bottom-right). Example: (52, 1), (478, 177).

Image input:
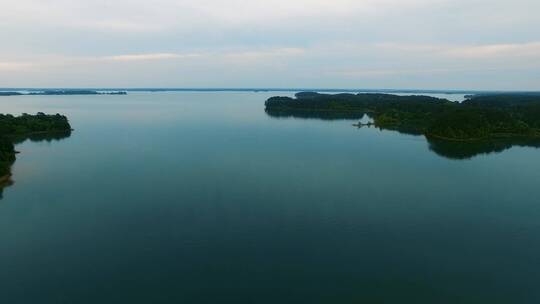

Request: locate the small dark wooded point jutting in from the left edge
(0, 112), (71, 196)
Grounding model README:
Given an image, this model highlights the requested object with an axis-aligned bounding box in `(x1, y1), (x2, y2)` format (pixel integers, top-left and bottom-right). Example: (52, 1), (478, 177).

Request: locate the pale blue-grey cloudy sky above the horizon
(0, 0), (540, 90)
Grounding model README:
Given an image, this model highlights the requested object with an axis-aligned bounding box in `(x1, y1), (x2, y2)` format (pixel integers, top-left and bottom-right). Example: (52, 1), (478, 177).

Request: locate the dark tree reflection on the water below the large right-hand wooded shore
(265, 109), (540, 160)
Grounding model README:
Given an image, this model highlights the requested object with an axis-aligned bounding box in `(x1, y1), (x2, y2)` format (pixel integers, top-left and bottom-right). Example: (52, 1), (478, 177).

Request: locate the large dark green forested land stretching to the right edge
(265, 92), (540, 142)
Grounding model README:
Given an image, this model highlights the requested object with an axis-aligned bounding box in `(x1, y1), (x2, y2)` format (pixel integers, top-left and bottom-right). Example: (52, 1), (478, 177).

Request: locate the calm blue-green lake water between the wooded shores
(0, 92), (540, 304)
